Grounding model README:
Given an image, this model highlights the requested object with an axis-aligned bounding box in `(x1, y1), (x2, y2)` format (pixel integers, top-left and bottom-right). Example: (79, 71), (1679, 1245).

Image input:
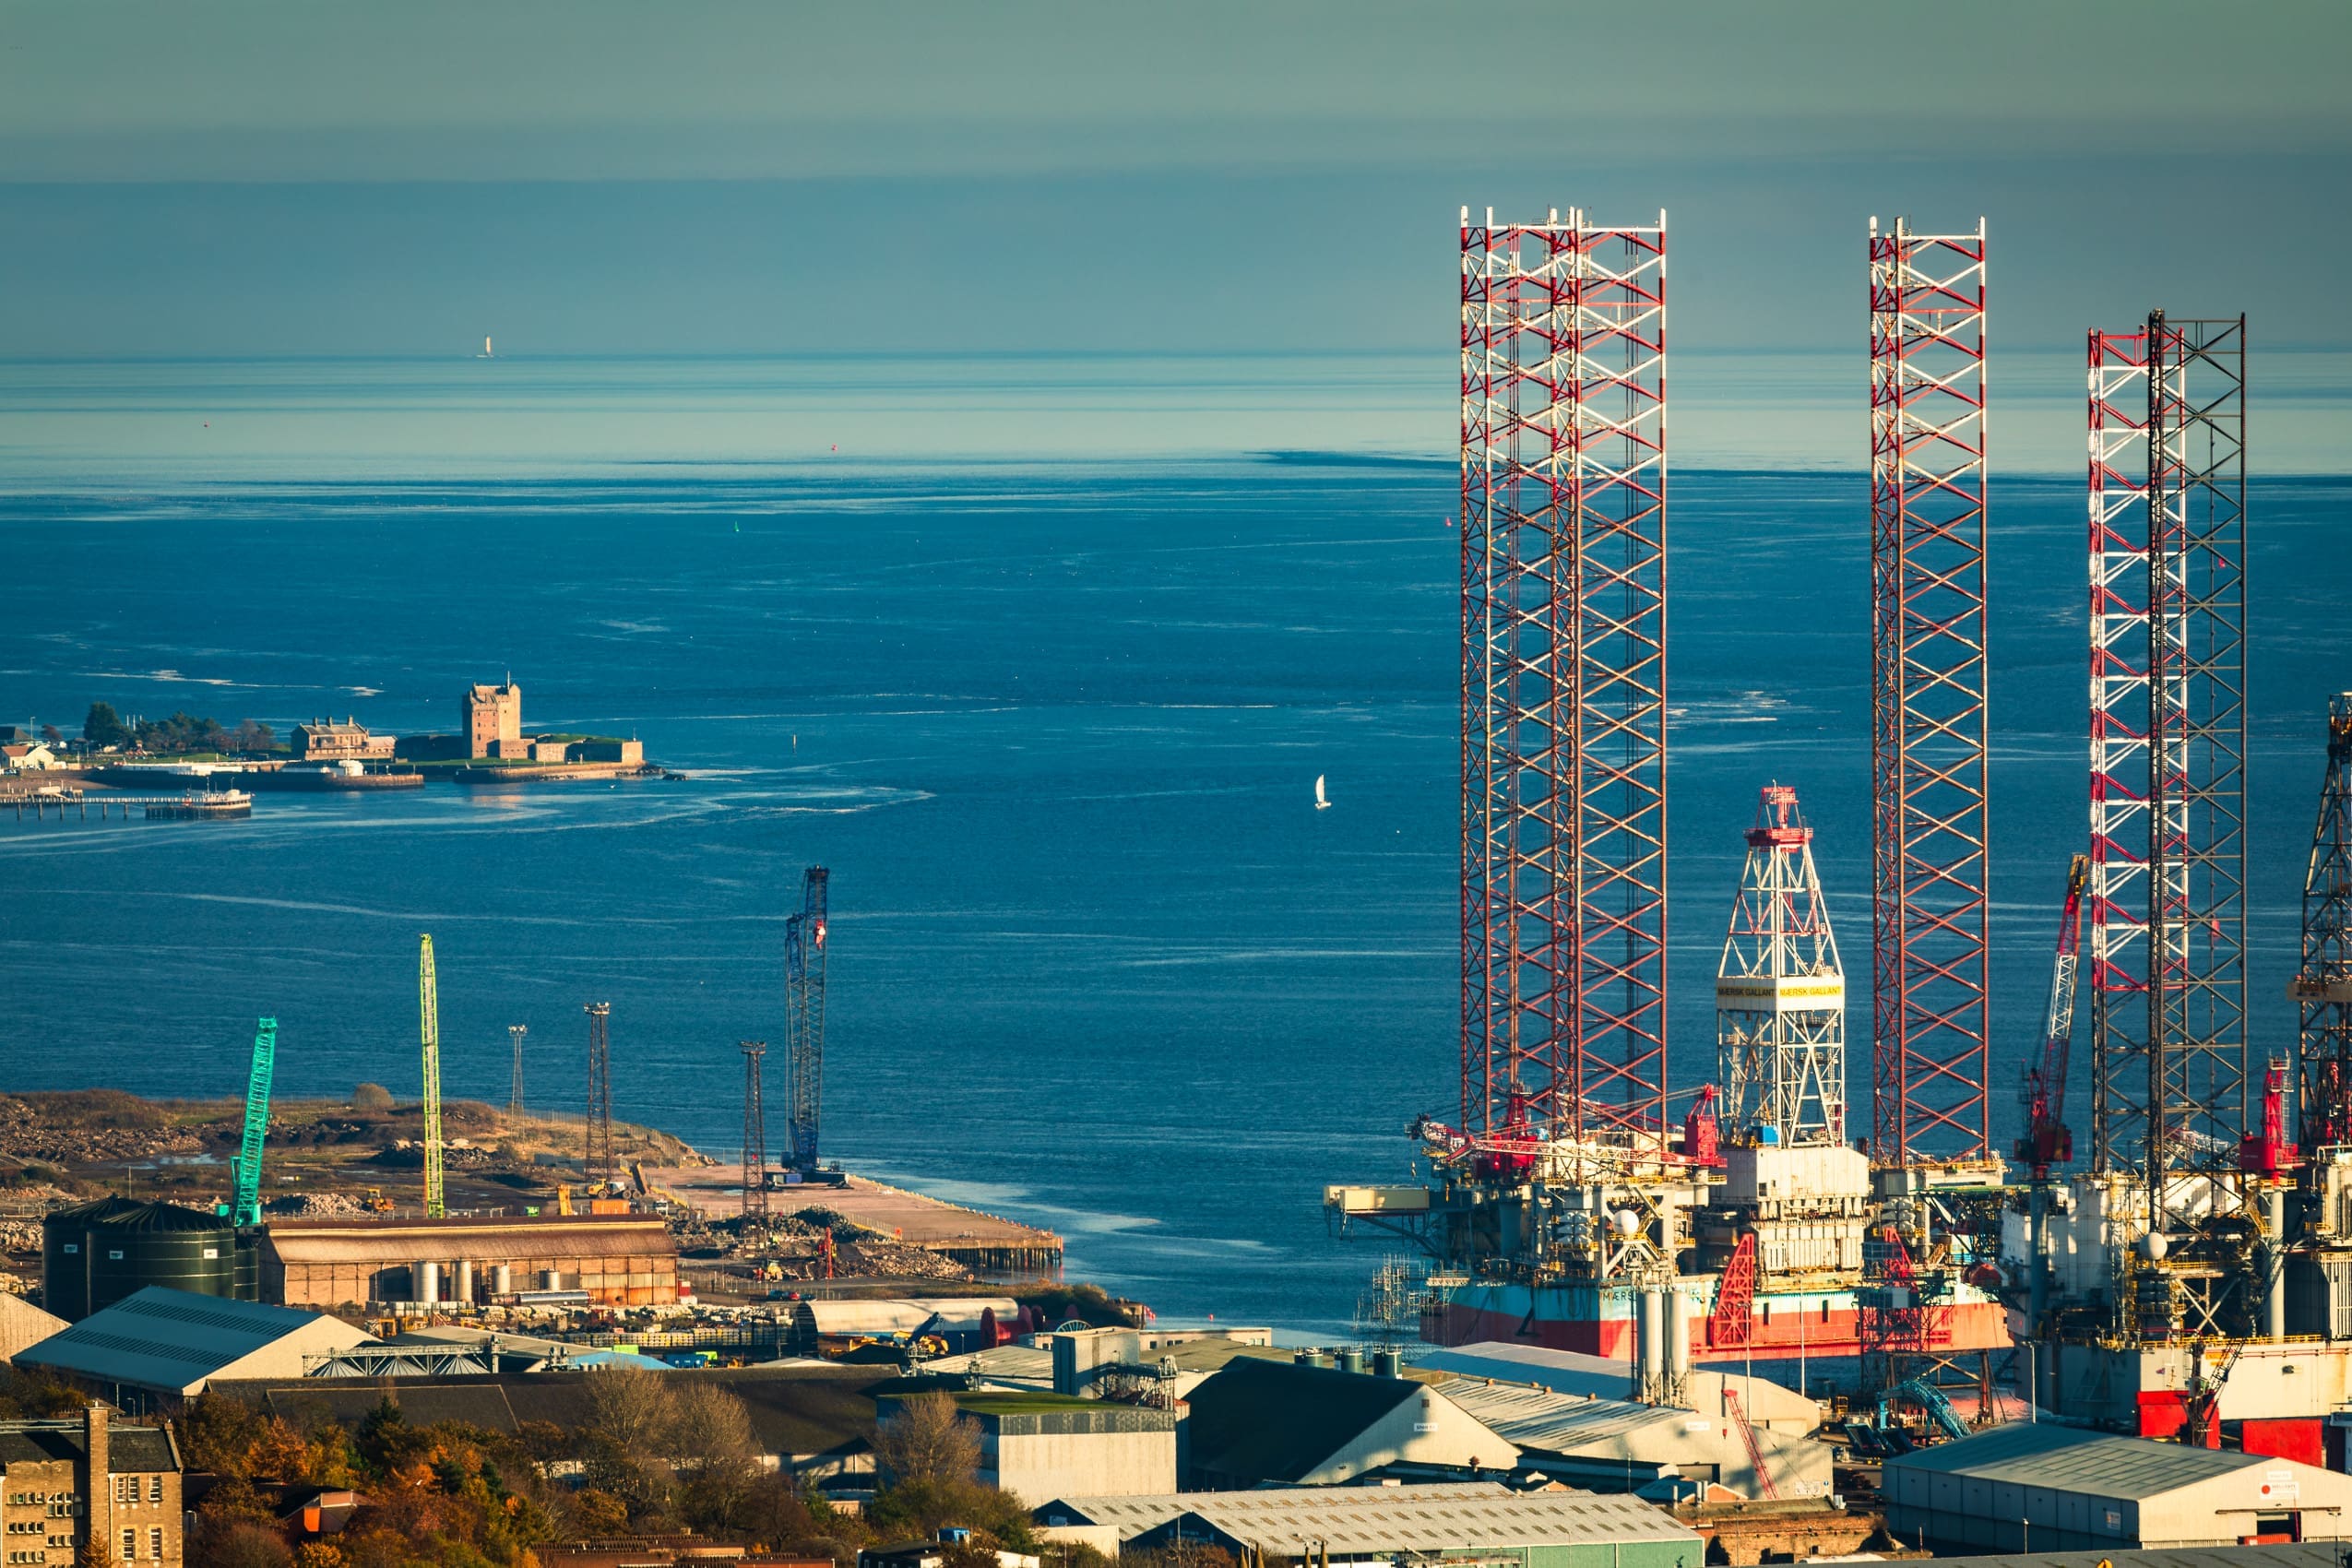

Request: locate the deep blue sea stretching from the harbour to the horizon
(0, 357), (2352, 1333)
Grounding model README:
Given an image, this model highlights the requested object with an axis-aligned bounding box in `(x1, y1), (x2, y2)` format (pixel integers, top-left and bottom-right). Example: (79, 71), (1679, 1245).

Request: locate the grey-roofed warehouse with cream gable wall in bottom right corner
(1879, 1425), (2352, 1554)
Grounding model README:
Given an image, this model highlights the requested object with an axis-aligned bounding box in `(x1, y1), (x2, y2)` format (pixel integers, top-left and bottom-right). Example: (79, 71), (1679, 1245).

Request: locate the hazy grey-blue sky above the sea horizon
(0, 0), (2352, 434)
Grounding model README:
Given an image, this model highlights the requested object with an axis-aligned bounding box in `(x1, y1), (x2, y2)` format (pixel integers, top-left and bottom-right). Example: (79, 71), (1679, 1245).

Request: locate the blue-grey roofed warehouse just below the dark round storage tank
(14, 1286), (374, 1415)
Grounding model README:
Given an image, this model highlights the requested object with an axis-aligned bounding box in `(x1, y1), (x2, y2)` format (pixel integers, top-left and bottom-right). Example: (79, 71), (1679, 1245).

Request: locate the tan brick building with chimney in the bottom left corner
(0, 1404), (181, 1568)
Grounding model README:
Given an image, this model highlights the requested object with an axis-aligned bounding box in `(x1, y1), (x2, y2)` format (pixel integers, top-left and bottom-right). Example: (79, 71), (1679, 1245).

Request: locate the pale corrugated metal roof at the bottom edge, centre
(1032, 1483), (1698, 1556)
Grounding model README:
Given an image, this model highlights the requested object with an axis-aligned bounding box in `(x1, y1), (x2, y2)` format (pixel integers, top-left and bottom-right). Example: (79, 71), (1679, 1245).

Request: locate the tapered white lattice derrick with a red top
(1715, 785), (1847, 1143)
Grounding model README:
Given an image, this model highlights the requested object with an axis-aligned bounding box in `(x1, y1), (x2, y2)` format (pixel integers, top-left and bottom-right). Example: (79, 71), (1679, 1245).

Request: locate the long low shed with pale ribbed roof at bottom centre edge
(1032, 1483), (1705, 1568)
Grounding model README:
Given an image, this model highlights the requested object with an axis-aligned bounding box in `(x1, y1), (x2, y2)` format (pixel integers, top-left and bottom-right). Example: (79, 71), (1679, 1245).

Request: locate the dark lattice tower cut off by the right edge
(2296, 691), (2352, 1147)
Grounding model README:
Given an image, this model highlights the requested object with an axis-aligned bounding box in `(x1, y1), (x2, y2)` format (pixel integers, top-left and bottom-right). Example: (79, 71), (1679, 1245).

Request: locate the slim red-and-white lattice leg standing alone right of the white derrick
(1870, 219), (1990, 1166)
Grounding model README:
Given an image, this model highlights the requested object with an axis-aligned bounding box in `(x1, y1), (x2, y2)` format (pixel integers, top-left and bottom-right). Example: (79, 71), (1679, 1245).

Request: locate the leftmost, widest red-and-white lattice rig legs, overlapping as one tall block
(1461, 209), (1665, 1152)
